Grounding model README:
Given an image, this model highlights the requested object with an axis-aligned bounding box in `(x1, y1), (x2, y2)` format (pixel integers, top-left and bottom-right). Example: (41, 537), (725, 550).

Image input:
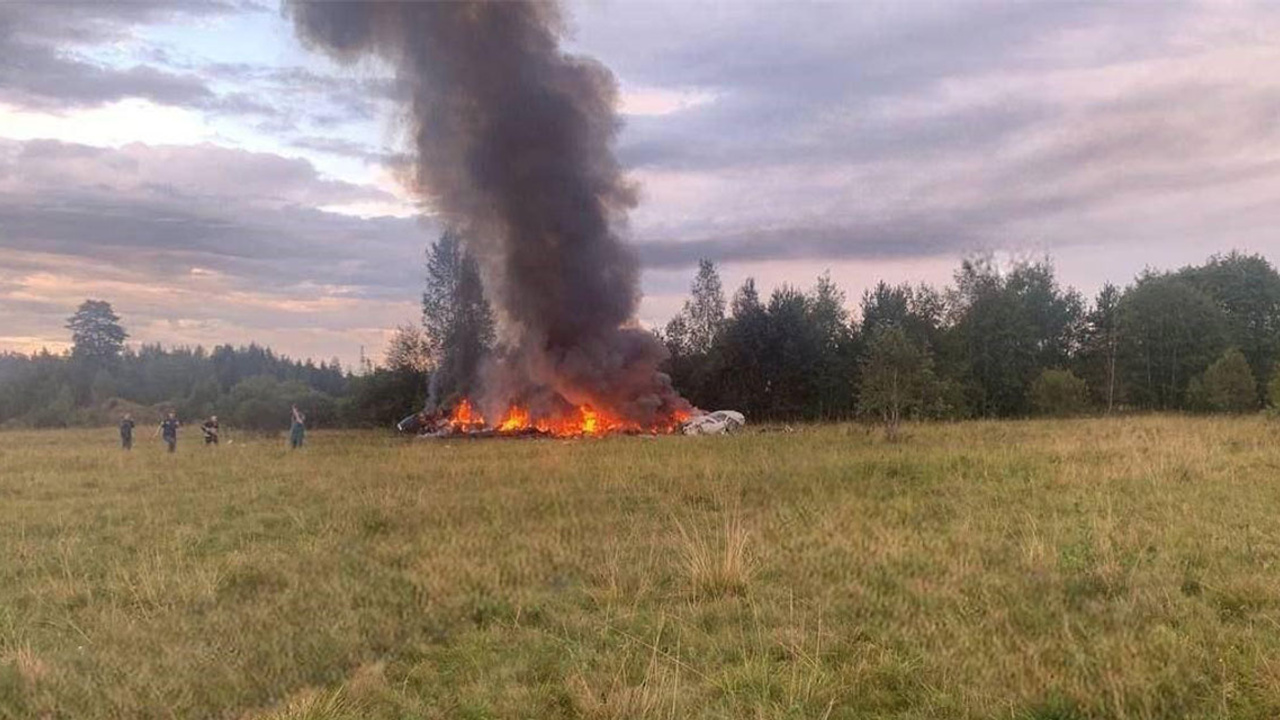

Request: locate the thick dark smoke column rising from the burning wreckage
(287, 1), (686, 421)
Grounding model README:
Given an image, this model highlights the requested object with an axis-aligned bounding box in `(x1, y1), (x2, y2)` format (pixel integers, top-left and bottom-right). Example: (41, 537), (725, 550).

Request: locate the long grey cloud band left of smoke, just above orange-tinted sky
(0, 197), (431, 299)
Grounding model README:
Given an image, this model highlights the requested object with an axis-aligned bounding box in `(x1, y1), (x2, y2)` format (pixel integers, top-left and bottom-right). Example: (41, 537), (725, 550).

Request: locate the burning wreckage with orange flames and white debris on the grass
(396, 400), (746, 438)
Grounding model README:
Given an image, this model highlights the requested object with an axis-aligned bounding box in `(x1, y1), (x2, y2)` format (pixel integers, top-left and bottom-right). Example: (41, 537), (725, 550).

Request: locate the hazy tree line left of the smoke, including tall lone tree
(0, 233), (494, 430)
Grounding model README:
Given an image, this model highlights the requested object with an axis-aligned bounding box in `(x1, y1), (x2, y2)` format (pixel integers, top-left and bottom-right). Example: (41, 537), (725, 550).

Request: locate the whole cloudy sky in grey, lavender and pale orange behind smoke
(0, 0), (1280, 364)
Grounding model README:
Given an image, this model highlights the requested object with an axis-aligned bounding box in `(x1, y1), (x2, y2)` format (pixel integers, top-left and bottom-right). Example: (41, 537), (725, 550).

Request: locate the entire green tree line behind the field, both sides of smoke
(0, 243), (1280, 429)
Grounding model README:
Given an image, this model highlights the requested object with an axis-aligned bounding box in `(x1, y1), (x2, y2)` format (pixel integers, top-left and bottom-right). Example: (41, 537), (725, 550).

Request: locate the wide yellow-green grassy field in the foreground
(0, 418), (1280, 720)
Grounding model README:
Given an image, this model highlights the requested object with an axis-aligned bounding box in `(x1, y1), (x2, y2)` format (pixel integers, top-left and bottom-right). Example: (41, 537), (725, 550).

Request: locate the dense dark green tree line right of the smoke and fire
(660, 252), (1280, 425)
